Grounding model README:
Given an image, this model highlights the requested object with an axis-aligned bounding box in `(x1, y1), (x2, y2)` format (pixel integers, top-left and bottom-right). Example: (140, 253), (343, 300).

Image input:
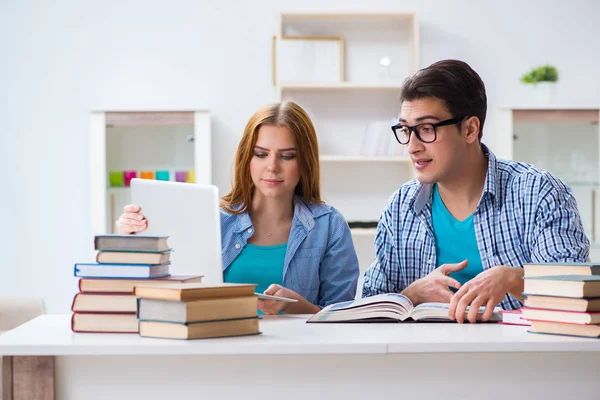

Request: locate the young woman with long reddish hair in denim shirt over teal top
(117, 102), (359, 314)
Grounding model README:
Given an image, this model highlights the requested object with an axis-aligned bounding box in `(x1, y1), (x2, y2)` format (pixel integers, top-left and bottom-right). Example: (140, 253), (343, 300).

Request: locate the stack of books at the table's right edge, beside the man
(522, 263), (600, 338)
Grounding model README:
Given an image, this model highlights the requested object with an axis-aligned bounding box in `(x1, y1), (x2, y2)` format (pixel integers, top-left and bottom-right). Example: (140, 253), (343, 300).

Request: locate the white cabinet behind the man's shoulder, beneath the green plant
(498, 105), (600, 248)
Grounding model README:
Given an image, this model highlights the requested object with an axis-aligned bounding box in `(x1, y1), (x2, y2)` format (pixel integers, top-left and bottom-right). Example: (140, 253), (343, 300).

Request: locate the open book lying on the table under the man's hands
(307, 293), (502, 322)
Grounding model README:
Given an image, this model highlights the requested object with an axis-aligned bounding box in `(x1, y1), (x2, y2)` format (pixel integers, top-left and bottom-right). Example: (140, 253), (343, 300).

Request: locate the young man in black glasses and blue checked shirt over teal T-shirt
(362, 60), (589, 323)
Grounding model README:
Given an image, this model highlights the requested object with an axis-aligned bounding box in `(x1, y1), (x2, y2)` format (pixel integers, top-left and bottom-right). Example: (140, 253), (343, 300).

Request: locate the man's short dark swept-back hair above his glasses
(400, 60), (487, 140)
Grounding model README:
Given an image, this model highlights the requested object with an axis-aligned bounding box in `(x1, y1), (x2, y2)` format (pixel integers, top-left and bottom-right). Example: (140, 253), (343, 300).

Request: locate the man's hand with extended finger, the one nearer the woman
(402, 260), (468, 306)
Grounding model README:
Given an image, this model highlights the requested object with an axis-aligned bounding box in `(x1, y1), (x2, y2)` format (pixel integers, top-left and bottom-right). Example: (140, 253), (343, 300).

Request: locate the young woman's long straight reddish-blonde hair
(221, 101), (322, 214)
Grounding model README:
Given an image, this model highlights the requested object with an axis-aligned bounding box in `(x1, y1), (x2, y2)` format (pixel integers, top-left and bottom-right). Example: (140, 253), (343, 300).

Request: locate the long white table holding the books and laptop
(0, 315), (600, 400)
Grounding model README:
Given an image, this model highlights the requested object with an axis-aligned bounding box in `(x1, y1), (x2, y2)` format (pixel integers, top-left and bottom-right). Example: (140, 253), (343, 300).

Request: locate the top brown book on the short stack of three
(133, 283), (257, 301)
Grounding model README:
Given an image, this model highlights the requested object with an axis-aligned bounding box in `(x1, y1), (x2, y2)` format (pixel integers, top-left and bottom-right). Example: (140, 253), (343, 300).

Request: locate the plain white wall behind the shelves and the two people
(0, 0), (600, 312)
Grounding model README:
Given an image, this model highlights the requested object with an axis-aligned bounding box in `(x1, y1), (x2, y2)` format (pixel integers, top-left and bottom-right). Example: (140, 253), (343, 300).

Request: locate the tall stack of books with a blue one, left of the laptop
(71, 235), (202, 333)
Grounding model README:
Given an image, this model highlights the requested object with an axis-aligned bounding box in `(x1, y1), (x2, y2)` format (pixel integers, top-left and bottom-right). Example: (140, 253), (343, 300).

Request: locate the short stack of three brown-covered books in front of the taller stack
(134, 283), (260, 339)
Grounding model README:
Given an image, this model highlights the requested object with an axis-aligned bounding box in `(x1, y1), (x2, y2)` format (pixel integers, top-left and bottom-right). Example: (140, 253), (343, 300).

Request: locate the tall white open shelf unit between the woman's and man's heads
(273, 12), (419, 227)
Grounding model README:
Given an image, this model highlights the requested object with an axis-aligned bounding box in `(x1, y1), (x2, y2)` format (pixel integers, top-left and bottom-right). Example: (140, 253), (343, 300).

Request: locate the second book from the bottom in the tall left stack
(71, 293), (137, 314)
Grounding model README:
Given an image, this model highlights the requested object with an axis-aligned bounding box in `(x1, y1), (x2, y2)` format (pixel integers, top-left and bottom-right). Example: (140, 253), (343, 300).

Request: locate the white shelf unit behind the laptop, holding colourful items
(89, 110), (212, 235)
